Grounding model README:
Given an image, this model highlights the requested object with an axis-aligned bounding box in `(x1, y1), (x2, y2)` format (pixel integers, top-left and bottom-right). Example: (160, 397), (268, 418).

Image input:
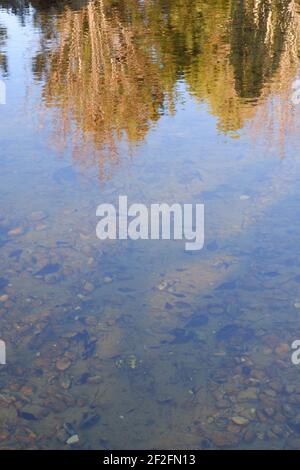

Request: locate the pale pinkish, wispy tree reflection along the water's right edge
(243, 0), (300, 157)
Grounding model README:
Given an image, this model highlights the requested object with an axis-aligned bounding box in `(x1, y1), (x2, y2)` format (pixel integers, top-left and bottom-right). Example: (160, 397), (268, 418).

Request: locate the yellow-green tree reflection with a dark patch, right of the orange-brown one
(179, 0), (300, 133)
